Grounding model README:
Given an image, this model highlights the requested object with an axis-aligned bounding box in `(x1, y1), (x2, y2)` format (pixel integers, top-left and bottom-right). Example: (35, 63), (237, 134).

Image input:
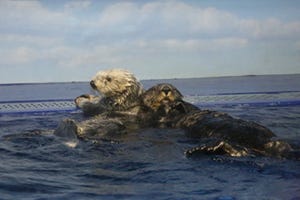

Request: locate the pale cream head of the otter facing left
(90, 69), (143, 97)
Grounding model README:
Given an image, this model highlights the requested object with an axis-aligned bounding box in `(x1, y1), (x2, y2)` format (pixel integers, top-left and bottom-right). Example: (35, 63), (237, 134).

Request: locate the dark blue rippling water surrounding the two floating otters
(0, 75), (300, 200)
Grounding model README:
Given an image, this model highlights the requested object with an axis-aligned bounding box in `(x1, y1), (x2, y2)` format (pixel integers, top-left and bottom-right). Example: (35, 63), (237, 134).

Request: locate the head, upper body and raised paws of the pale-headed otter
(75, 69), (144, 116)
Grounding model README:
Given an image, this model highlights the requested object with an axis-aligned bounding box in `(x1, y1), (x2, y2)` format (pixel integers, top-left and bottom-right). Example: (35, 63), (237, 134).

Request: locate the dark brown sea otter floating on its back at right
(142, 83), (292, 157)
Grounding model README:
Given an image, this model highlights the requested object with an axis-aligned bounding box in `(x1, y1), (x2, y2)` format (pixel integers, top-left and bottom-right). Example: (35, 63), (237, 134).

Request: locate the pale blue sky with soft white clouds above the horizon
(0, 0), (300, 83)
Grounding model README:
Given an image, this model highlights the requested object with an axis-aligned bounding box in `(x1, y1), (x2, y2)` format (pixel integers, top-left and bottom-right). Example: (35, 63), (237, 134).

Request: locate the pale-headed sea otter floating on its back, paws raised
(54, 69), (153, 139)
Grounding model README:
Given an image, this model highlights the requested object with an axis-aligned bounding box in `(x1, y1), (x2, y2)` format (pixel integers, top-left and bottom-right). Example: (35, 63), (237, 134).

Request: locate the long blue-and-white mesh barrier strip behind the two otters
(0, 92), (300, 114)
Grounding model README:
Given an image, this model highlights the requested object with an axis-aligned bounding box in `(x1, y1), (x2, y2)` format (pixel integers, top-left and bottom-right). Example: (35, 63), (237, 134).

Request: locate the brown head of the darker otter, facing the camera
(142, 83), (183, 111)
